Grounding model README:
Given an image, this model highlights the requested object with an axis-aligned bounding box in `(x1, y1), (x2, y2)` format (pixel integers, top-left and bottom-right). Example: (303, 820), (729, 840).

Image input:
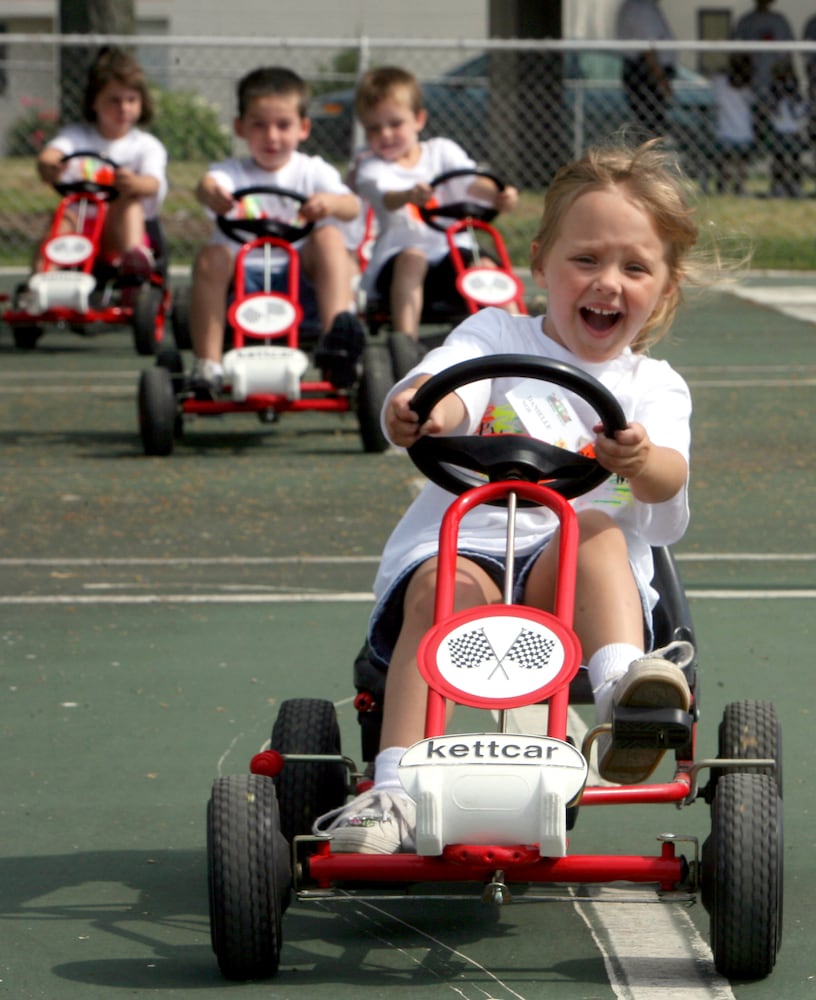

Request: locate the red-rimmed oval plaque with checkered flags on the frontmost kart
(419, 605), (581, 708)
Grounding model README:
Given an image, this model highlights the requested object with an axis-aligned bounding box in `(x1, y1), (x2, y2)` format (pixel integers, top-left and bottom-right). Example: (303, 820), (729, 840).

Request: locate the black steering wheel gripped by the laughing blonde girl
(408, 354), (626, 506)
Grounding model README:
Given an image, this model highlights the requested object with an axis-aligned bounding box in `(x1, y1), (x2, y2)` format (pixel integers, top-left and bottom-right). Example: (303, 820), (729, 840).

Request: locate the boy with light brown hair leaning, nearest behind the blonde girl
(354, 66), (518, 338)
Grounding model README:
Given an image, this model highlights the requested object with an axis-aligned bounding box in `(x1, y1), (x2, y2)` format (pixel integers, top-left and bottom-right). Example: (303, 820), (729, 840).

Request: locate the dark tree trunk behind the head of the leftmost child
(59, 0), (136, 122)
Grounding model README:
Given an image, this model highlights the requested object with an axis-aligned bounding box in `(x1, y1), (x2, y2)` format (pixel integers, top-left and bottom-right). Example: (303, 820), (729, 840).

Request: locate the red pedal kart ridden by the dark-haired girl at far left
(3, 151), (170, 355)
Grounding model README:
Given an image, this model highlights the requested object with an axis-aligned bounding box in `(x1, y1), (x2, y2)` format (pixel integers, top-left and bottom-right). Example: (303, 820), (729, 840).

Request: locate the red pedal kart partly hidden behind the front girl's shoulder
(365, 167), (527, 380)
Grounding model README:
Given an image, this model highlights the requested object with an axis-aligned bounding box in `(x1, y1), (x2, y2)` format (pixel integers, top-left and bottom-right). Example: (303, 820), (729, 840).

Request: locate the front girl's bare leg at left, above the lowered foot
(380, 557), (501, 750)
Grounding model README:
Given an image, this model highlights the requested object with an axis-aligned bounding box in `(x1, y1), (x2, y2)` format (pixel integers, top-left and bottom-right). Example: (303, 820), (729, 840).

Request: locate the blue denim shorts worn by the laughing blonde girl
(368, 542), (654, 671)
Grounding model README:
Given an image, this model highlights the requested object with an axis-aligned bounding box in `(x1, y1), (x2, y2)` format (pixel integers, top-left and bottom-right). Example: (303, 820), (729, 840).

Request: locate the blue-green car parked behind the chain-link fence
(306, 50), (715, 176)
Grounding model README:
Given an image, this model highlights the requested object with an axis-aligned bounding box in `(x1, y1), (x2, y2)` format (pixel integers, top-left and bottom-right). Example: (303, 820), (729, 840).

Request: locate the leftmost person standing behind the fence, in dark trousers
(617, 0), (676, 136)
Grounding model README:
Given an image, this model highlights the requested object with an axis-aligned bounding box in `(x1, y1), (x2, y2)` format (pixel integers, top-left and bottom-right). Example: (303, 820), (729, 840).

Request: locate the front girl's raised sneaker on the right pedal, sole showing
(597, 641), (694, 785)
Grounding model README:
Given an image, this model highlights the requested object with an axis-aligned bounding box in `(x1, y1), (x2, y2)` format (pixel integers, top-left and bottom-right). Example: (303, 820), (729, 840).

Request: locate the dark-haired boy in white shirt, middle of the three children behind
(190, 67), (363, 398)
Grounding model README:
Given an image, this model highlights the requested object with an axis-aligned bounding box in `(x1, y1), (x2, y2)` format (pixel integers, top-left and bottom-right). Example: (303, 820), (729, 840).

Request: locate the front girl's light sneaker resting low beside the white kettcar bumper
(312, 788), (416, 854)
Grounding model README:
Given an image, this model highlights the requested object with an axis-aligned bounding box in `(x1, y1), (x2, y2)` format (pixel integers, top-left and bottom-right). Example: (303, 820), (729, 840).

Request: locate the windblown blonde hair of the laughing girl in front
(532, 139), (719, 352)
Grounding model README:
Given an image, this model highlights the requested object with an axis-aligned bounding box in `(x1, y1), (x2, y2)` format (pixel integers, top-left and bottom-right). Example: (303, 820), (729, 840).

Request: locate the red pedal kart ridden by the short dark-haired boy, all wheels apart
(139, 186), (393, 455)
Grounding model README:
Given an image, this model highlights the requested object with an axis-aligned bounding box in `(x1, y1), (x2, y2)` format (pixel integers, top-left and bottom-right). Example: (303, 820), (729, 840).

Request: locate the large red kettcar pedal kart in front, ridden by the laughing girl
(208, 355), (783, 979)
